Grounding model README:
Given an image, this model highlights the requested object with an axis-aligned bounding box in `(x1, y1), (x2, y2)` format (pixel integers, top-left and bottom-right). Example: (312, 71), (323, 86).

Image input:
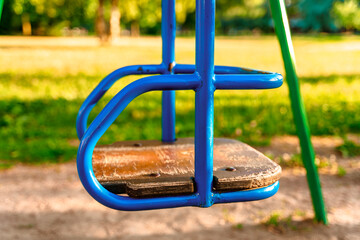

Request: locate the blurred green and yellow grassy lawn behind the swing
(0, 36), (360, 164)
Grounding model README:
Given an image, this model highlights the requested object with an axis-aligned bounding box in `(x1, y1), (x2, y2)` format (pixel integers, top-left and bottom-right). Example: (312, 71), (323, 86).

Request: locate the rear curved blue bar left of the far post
(76, 65), (165, 139)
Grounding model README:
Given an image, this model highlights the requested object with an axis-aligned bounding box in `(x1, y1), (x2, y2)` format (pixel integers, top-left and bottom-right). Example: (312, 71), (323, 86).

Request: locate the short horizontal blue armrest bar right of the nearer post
(215, 73), (283, 89)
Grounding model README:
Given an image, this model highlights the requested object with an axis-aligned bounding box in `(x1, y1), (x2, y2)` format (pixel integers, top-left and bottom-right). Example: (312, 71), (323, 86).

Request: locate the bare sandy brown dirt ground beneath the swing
(0, 137), (360, 240)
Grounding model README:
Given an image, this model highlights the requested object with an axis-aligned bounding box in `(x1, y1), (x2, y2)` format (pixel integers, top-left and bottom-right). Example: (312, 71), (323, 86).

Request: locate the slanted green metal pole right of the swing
(270, 0), (327, 224)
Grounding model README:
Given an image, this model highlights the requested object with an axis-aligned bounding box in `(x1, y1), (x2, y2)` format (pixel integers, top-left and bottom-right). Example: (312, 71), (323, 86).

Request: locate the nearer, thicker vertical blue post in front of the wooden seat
(195, 0), (215, 207)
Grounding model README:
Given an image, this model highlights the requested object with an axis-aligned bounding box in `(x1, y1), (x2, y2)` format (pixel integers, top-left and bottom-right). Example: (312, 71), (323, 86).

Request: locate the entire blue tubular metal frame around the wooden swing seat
(76, 0), (283, 211)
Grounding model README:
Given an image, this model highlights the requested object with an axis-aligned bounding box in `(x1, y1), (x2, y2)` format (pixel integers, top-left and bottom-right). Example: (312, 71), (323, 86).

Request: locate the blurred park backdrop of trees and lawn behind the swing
(0, 0), (360, 168)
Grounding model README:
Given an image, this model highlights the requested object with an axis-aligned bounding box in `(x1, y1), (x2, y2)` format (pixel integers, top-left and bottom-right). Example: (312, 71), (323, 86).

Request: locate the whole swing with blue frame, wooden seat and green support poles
(0, 0), (327, 224)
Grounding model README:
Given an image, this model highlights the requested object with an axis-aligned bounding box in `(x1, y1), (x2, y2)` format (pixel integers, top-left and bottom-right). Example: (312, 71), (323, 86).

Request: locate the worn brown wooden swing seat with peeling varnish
(92, 138), (281, 198)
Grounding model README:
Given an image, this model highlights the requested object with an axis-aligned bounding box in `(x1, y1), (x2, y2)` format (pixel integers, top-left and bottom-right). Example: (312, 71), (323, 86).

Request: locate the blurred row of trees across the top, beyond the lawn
(0, 0), (360, 36)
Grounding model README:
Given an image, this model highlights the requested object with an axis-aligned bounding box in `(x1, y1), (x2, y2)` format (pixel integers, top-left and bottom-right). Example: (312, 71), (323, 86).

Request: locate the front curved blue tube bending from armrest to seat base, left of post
(77, 75), (200, 210)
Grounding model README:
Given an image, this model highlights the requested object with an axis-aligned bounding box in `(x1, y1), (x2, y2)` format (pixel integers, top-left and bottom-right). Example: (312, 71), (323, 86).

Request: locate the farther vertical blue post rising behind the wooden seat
(161, 0), (176, 142)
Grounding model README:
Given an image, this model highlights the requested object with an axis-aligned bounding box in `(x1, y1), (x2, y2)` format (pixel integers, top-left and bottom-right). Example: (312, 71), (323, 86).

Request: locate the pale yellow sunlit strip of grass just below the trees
(0, 36), (360, 77)
